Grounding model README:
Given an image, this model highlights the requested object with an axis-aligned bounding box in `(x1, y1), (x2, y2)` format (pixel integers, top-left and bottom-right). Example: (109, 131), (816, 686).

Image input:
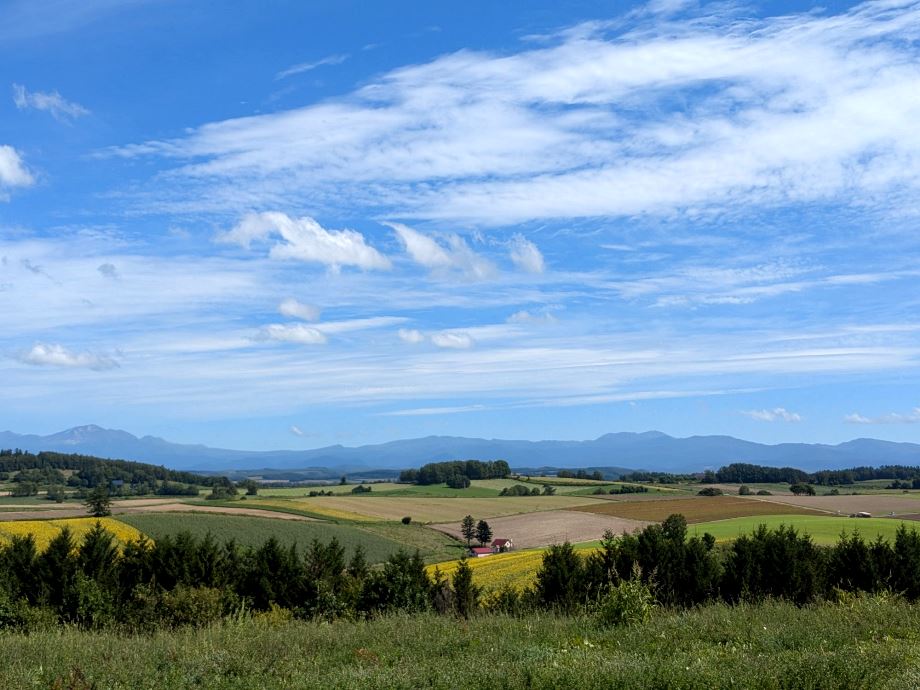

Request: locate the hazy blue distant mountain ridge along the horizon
(0, 425), (920, 472)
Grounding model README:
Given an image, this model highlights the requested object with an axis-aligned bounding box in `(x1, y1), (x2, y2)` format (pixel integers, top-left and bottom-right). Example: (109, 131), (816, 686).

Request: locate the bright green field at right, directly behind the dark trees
(687, 515), (916, 545)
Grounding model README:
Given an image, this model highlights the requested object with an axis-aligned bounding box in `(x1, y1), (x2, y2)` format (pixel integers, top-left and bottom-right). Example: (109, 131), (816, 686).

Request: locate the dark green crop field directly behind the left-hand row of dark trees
(120, 513), (403, 563)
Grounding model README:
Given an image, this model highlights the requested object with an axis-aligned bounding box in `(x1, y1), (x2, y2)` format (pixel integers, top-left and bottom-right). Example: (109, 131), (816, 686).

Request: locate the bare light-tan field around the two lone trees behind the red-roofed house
(431, 510), (649, 549)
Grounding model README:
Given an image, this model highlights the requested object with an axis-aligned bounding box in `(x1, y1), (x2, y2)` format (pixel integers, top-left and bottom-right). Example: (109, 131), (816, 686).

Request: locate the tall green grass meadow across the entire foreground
(0, 595), (920, 690)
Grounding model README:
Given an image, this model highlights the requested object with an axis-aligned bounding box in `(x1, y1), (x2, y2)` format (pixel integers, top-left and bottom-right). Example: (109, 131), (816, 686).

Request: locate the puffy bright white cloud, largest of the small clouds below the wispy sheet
(217, 212), (390, 270)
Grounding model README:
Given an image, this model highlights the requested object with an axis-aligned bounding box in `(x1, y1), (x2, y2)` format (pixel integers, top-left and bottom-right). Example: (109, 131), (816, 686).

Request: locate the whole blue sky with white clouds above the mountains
(0, 0), (920, 449)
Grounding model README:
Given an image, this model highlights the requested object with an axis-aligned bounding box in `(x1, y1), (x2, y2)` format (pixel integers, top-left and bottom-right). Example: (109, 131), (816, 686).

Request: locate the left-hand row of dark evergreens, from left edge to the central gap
(0, 523), (478, 629)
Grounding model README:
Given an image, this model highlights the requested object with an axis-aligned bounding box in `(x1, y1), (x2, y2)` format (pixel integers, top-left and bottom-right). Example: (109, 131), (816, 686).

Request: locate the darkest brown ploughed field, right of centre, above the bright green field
(572, 496), (816, 522)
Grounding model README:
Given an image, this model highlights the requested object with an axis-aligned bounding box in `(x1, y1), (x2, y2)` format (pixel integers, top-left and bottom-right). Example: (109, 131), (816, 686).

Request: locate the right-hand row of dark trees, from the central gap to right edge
(533, 515), (920, 610)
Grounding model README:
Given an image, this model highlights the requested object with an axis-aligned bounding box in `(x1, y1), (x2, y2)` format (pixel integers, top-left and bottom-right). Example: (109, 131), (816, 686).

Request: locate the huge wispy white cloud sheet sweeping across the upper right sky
(109, 2), (920, 225)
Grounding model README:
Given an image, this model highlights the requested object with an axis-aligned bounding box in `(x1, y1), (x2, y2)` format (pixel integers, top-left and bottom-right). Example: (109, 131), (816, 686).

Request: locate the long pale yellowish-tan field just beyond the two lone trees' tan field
(290, 496), (598, 522)
